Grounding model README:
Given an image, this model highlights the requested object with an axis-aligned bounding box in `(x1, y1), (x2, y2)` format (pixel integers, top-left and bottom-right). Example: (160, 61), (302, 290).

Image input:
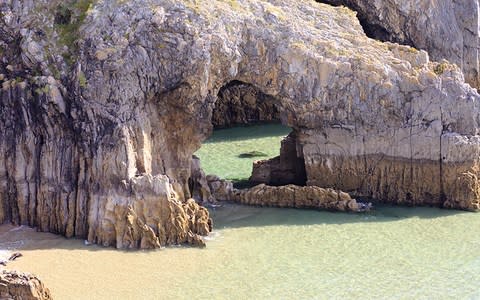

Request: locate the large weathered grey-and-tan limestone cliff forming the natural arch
(0, 0), (480, 248)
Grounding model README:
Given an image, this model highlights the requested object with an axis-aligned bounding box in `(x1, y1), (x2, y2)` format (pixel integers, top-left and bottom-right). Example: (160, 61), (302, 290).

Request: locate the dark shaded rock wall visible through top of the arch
(212, 81), (280, 128)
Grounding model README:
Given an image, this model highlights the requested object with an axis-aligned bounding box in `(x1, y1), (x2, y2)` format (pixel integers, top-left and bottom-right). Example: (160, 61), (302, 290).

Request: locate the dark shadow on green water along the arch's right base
(209, 203), (473, 229)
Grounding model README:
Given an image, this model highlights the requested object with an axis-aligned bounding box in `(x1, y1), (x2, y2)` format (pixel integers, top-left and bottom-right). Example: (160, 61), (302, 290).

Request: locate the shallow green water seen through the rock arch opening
(195, 124), (292, 180)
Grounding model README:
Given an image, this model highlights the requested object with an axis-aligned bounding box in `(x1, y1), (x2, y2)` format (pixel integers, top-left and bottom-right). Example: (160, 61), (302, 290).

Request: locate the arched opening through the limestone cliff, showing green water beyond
(195, 81), (306, 192)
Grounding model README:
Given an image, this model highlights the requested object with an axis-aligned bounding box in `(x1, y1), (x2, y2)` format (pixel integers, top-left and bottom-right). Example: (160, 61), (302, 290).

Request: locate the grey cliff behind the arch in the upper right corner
(319, 0), (480, 88)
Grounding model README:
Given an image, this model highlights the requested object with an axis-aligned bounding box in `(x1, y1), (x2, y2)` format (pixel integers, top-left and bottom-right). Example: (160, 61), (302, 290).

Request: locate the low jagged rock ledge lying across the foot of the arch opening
(230, 184), (370, 212)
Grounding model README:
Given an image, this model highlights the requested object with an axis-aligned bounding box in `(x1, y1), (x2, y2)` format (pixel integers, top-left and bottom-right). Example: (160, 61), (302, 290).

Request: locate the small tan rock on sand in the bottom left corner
(0, 270), (53, 300)
